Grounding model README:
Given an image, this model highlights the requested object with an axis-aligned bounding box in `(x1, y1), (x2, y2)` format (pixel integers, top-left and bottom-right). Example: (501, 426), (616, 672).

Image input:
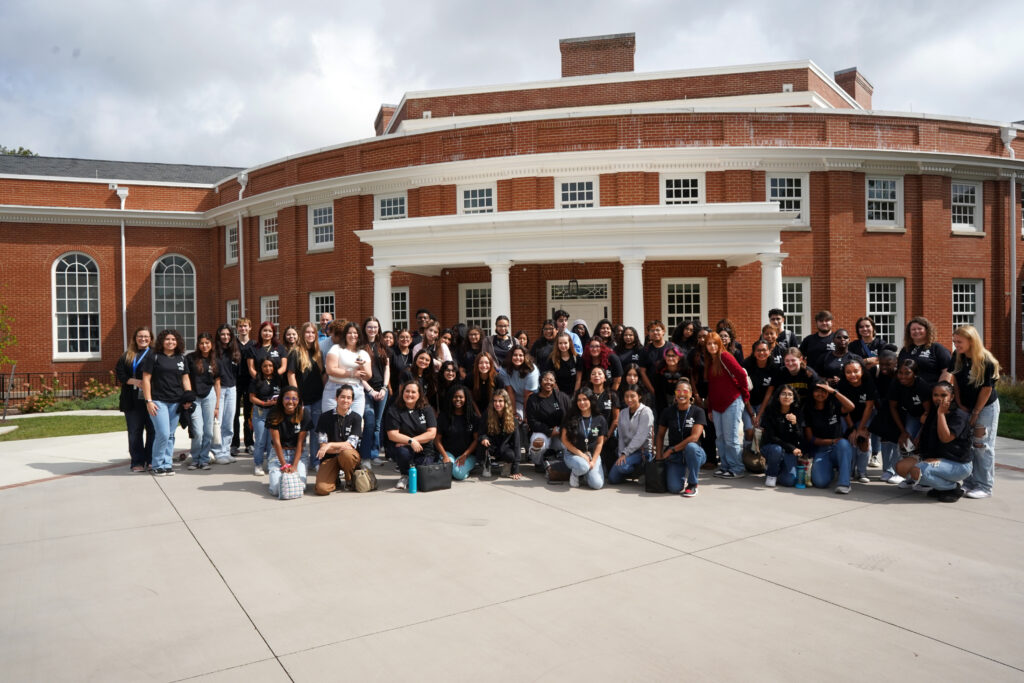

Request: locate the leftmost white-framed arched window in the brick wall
(53, 253), (100, 360)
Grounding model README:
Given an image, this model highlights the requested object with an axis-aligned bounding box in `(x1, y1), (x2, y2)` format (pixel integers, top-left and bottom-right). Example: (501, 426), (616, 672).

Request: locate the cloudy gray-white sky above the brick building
(0, 0), (1024, 166)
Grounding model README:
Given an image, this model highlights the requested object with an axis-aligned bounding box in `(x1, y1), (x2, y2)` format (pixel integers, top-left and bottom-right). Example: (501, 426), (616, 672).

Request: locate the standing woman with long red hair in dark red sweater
(703, 332), (751, 479)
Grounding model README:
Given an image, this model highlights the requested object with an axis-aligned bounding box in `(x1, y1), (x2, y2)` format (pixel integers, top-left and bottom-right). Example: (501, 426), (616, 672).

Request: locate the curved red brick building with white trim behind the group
(0, 34), (1024, 372)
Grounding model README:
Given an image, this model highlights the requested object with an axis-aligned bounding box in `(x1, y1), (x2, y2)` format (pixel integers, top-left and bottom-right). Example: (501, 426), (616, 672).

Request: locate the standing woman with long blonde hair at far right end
(948, 325), (999, 499)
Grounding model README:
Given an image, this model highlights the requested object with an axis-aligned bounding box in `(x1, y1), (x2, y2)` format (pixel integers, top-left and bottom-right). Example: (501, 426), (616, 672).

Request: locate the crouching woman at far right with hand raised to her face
(896, 382), (973, 503)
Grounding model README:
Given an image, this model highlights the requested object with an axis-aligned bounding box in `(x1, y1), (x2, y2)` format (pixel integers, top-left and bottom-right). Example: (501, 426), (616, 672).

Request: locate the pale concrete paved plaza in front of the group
(0, 419), (1024, 683)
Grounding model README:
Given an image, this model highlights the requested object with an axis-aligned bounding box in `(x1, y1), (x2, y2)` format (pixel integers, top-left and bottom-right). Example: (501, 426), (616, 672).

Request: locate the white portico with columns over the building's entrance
(356, 202), (796, 330)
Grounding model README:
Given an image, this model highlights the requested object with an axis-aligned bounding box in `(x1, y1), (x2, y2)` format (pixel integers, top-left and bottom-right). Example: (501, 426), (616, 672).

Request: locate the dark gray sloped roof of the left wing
(0, 155), (245, 184)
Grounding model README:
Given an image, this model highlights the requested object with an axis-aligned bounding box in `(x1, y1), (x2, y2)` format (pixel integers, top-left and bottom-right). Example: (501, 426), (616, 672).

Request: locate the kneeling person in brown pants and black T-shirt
(314, 384), (362, 496)
